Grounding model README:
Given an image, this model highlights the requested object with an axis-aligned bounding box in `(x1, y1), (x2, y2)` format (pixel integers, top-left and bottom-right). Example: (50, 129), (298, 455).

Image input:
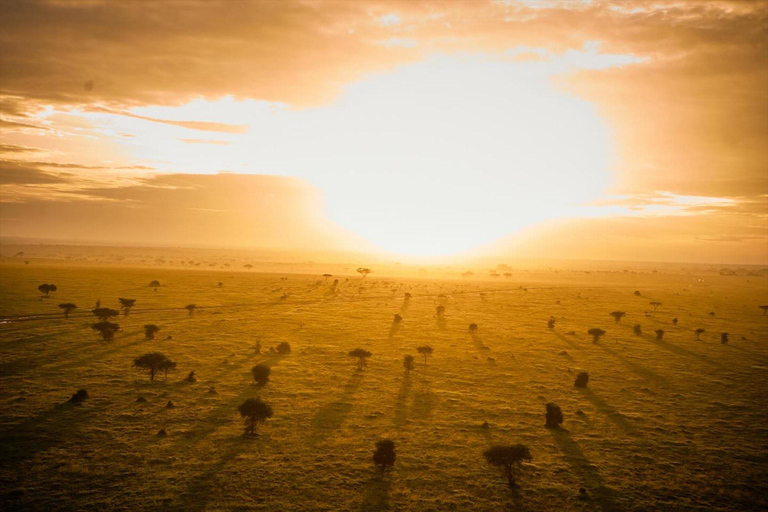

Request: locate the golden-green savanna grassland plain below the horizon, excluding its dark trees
(0, 260), (768, 511)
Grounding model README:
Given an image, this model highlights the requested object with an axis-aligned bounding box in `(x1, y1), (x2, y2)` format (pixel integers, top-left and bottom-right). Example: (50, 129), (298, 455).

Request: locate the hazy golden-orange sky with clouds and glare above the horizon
(0, 0), (768, 263)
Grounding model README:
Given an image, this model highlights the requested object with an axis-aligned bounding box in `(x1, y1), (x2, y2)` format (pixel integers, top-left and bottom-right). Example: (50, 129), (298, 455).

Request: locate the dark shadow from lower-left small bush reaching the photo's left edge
(0, 402), (106, 465)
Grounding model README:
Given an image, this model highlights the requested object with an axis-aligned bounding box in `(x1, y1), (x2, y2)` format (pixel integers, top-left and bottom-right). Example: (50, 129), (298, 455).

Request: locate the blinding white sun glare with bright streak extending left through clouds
(84, 56), (610, 256)
